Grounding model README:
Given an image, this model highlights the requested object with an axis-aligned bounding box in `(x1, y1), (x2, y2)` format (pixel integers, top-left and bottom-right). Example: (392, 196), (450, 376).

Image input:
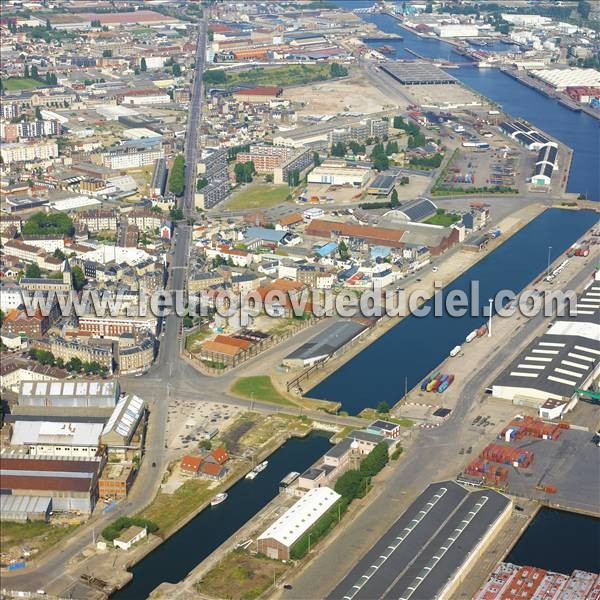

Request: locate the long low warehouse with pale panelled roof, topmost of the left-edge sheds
(19, 379), (119, 410)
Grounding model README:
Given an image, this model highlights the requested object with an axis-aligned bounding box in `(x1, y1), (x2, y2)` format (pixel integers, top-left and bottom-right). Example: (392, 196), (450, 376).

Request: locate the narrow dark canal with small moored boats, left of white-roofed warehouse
(111, 431), (331, 600)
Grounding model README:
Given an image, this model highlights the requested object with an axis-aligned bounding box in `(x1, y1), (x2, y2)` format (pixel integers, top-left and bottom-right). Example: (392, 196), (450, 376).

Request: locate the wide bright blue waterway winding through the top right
(344, 1), (600, 200)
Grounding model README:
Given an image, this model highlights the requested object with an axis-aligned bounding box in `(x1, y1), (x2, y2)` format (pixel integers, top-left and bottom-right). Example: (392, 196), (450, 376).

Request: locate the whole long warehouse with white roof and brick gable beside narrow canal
(257, 487), (341, 560)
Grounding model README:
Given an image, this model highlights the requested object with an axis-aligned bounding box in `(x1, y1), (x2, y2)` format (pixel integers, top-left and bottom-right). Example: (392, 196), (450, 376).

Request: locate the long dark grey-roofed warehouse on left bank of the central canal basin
(283, 320), (368, 368)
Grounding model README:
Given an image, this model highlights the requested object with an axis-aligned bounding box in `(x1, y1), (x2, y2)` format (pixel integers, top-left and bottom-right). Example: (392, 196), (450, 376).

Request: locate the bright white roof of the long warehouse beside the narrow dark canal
(258, 487), (341, 548)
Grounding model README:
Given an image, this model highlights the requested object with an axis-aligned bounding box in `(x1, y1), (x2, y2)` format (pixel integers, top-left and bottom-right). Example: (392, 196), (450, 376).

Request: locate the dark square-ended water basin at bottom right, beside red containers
(504, 508), (600, 575)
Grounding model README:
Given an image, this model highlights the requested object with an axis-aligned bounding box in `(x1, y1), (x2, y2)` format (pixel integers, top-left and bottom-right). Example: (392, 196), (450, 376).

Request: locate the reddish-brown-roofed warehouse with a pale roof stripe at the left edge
(0, 452), (105, 514)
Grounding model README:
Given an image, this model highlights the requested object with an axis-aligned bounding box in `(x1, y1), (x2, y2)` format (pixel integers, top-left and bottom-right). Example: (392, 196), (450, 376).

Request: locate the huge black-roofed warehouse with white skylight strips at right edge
(492, 280), (600, 418)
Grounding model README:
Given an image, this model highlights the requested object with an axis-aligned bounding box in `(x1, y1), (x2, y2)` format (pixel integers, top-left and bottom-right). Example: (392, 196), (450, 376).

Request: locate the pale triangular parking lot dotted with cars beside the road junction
(167, 400), (242, 451)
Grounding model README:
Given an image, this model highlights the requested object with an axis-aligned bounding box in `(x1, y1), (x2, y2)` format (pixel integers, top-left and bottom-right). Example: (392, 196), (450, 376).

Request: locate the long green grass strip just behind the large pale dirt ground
(209, 64), (331, 87)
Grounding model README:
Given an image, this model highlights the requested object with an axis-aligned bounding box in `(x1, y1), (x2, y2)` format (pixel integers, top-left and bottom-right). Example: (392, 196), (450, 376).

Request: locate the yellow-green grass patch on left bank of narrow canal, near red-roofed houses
(136, 479), (216, 534)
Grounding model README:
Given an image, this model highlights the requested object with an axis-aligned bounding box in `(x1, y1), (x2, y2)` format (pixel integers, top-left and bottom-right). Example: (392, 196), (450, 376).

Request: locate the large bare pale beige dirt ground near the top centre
(283, 74), (398, 116)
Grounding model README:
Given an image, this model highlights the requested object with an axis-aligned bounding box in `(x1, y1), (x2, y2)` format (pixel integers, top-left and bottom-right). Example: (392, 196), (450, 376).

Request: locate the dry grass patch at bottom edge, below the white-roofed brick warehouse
(196, 550), (288, 600)
